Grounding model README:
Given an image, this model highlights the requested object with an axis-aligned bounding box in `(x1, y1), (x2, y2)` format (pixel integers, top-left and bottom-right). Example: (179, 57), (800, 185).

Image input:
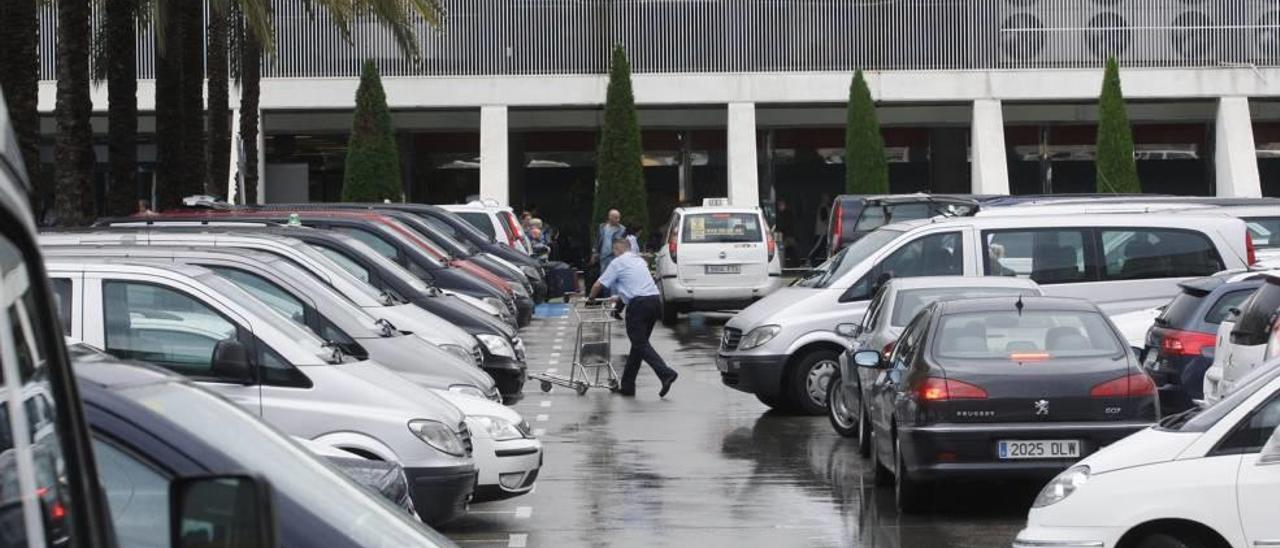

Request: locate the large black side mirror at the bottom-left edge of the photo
(169, 475), (278, 548)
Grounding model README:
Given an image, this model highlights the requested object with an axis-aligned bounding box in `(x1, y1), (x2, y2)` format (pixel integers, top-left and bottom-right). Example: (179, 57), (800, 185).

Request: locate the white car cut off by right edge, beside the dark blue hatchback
(1204, 273), (1280, 403)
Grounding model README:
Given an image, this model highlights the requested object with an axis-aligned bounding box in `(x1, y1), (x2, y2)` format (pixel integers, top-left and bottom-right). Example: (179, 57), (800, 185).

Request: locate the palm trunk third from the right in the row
(182, 0), (209, 196)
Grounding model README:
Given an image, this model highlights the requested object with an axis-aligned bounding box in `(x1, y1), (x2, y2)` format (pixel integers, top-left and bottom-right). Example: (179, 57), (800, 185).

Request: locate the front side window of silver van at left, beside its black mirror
(102, 282), (239, 379)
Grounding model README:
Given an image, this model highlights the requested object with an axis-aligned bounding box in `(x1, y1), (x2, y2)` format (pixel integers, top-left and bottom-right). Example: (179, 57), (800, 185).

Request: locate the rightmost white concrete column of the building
(1213, 97), (1262, 198)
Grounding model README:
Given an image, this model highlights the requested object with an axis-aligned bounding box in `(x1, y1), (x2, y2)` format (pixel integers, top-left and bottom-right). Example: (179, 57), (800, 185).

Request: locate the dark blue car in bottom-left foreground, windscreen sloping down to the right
(76, 348), (454, 548)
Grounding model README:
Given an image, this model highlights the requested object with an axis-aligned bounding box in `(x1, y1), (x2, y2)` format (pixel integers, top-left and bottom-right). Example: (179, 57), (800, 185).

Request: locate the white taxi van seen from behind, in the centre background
(655, 206), (782, 325)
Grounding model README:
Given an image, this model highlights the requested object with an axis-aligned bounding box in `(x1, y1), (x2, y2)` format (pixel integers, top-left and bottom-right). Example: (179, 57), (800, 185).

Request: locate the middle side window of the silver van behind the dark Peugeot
(982, 229), (1096, 284)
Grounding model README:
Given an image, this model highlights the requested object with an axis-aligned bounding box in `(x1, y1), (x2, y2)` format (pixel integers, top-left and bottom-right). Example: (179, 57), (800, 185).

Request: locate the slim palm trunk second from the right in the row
(205, 4), (232, 196)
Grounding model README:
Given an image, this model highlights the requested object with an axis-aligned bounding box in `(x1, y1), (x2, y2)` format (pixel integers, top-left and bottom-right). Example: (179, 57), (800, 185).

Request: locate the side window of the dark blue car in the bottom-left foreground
(93, 435), (170, 548)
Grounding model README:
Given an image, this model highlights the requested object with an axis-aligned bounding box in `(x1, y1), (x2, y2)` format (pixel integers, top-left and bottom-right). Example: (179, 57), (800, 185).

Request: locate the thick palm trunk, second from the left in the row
(54, 0), (93, 227)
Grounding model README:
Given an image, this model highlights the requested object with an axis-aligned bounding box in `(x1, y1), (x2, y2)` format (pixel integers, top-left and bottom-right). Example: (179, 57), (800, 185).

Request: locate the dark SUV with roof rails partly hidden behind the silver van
(827, 193), (978, 256)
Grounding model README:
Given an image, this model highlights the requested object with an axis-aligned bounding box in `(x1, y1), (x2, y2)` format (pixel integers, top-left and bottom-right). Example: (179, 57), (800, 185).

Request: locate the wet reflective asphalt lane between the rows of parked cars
(443, 314), (1039, 548)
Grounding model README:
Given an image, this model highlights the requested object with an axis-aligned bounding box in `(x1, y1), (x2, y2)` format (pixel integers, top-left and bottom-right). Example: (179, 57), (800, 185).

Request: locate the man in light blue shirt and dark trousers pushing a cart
(588, 239), (680, 397)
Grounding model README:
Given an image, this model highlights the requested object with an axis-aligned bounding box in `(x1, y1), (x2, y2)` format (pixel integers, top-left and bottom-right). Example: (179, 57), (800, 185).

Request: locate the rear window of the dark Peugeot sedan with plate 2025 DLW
(933, 309), (1121, 361)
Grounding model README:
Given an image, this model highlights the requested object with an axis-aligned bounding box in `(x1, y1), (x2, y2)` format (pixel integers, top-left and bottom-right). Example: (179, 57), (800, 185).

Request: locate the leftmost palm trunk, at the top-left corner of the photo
(0, 0), (45, 220)
